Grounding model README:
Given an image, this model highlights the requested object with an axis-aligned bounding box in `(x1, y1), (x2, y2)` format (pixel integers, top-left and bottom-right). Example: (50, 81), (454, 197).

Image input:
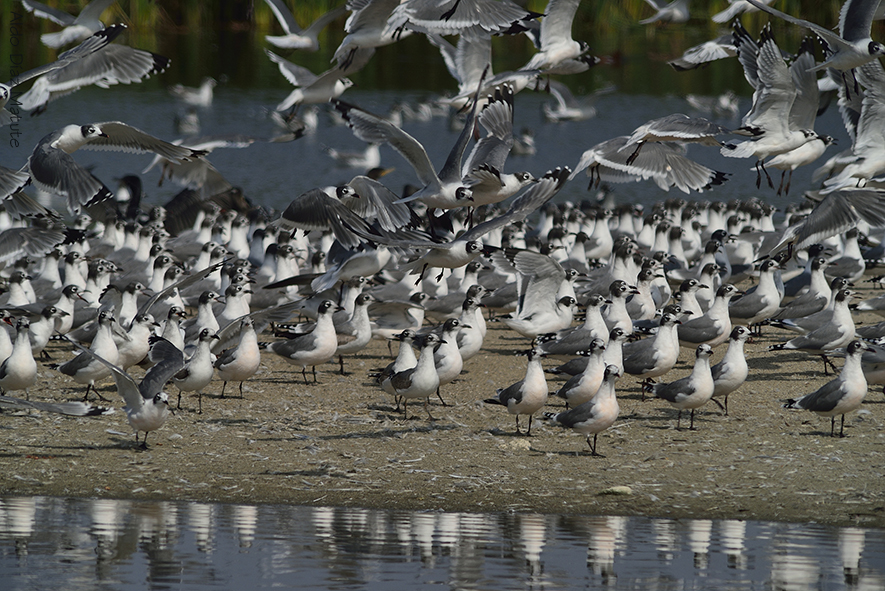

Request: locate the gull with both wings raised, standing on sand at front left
(64, 337), (184, 449)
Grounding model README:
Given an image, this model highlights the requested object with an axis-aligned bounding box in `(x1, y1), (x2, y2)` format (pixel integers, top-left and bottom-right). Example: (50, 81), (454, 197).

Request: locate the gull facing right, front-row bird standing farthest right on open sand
(784, 341), (876, 437)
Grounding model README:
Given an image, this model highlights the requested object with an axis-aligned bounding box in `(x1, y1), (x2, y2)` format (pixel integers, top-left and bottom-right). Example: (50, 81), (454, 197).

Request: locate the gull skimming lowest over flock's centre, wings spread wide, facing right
(353, 167), (570, 284)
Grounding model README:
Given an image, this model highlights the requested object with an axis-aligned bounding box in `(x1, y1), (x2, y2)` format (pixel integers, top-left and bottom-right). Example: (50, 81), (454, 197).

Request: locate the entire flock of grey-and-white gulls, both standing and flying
(0, 0), (885, 455)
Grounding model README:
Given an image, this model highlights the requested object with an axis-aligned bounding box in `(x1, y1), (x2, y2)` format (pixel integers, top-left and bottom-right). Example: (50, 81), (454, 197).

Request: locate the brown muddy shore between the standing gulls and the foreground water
(0, 290), (885, 527)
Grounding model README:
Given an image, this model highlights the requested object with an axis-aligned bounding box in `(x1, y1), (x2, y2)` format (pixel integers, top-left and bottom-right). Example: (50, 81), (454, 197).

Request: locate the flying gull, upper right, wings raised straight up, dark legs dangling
(720, 23), (818, 188)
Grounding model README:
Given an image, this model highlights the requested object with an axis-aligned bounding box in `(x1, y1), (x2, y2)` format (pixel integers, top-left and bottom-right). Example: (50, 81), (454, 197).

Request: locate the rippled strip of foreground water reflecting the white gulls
(0, 497), (885, 591)
